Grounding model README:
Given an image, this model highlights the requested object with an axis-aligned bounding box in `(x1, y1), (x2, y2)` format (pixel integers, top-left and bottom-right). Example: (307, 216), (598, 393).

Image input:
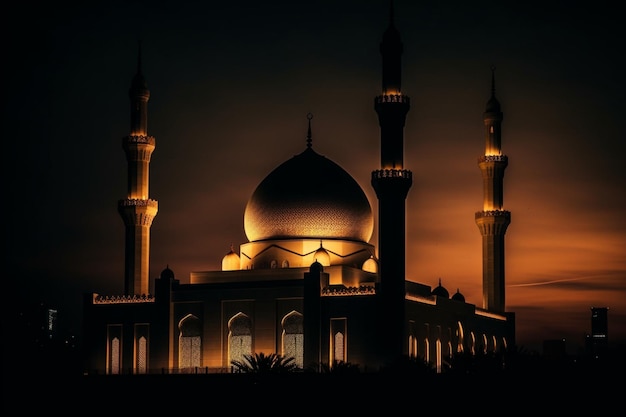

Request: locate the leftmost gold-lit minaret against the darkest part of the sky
(117, 48), (159, 295)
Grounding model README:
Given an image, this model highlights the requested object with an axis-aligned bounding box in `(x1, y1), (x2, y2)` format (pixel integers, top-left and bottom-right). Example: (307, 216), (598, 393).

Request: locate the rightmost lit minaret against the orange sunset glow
(475, 68), (511, 313)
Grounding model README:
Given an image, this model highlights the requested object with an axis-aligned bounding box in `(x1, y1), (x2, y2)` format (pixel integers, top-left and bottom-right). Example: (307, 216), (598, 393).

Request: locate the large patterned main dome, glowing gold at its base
(244, 146), (374, 242)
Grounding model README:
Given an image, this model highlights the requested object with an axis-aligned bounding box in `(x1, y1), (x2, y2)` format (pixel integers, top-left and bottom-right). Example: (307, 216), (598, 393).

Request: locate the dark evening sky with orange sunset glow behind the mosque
(2, 0), (626, 349)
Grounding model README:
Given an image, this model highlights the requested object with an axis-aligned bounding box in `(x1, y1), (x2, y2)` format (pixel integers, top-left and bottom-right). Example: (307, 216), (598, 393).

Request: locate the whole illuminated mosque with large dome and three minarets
(83, 4), (515, 374)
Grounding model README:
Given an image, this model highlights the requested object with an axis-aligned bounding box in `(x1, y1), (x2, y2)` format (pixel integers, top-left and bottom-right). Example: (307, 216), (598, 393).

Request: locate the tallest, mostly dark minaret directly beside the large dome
(372, 3), (413, 361)
